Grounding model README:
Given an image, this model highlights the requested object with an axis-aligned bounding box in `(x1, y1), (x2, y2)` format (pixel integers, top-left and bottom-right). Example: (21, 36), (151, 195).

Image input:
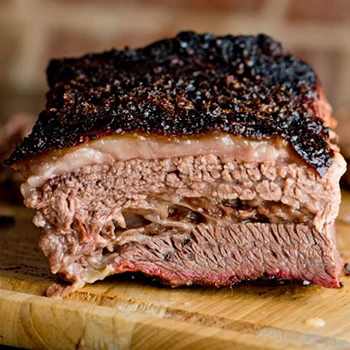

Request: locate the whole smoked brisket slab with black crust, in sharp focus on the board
(8, 32), (345, 296)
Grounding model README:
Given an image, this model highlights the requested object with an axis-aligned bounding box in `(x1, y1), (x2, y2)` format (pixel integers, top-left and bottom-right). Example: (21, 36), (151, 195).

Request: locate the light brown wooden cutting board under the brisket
(0, 193), (350, 350)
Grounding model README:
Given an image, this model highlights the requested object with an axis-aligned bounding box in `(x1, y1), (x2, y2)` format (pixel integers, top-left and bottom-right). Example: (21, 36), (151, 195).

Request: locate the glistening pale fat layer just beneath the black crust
(20, 134), (290, 197)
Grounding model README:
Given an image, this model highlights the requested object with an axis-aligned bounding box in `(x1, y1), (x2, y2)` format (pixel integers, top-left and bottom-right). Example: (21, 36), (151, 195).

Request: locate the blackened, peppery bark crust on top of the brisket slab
(7, 32), (334, 176)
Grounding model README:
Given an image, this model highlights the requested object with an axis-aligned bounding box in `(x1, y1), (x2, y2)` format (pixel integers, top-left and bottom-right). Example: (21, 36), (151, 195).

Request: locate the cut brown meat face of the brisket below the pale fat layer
(25, 155), (344, 295)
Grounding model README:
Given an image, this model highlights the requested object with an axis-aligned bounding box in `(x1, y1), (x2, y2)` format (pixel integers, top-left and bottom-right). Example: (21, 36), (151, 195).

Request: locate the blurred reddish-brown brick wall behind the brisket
(0, 0), (350, 120)
